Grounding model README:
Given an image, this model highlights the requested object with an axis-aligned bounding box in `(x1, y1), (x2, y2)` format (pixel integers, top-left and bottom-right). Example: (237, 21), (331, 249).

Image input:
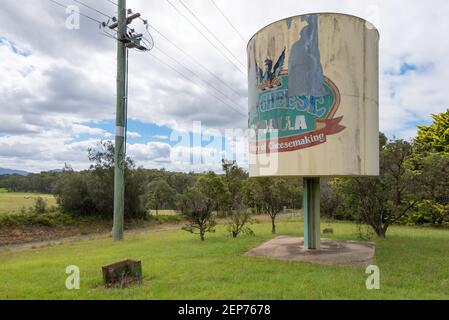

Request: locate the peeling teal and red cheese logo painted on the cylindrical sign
(249, 15), (345, 154)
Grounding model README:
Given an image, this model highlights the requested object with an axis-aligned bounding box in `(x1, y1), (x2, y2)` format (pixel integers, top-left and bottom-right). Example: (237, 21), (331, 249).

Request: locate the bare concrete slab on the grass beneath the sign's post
(245, 237), (376, 267)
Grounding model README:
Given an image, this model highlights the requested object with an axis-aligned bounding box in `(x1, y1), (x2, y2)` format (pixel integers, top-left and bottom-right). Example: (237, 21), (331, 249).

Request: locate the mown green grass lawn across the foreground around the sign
(0, 219), (449, 300)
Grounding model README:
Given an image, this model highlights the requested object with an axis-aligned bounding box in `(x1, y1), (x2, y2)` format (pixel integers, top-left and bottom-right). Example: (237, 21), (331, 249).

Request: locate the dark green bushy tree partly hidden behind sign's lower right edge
(334, 136), (421, 237)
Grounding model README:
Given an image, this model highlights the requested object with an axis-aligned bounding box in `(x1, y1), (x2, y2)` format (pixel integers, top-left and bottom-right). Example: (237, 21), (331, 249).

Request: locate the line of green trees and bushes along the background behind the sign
(0, 110), (449, 240)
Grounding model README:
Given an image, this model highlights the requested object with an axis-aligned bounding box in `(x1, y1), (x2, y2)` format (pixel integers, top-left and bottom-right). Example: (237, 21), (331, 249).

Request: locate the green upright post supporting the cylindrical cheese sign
(304, 178), (321, 250)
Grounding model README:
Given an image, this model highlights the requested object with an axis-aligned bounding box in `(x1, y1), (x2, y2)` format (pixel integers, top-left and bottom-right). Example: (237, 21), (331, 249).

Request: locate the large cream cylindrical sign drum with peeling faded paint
(248, 13), (379, 177)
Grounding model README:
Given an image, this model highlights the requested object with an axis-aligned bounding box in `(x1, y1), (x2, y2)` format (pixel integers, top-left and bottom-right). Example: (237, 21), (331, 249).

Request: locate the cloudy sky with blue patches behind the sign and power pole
(0, 0), (449, 172)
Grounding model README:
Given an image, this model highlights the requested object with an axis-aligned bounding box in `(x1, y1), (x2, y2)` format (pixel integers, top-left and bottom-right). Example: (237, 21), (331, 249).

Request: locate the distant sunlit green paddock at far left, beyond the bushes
(0, 189), (56, 214)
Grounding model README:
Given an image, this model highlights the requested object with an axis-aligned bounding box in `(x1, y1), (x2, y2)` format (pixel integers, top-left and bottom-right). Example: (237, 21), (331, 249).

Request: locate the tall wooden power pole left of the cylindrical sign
(112, 0), (128, 241)
